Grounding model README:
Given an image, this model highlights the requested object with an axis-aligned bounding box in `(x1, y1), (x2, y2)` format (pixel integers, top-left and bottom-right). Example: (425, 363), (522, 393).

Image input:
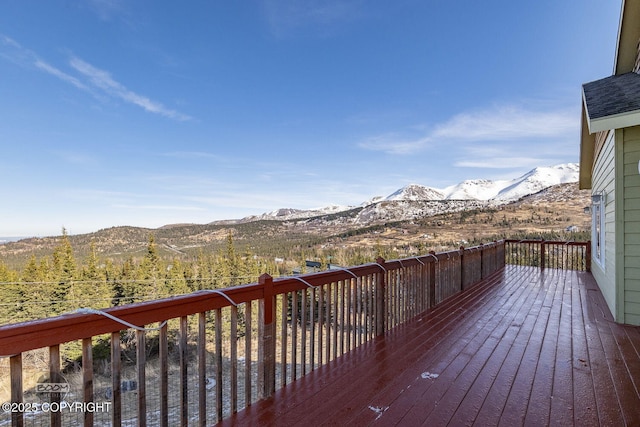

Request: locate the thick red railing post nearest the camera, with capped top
(258, 273), (276, 399)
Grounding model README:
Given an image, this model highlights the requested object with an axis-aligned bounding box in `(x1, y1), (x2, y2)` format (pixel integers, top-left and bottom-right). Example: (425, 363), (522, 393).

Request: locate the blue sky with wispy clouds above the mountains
(0, 0), (620, 236)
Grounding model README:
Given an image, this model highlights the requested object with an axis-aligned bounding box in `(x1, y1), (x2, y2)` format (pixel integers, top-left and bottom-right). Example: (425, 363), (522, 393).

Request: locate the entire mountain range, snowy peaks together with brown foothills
(0, 164), (590, 268)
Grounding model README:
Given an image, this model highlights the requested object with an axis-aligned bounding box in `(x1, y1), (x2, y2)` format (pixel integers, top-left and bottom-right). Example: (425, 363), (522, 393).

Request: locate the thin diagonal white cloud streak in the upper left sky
(69, 57), (191, 121)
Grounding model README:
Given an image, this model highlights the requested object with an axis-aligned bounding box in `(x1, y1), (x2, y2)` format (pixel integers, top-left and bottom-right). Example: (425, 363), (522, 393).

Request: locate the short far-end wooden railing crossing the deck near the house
(504, 240), (591, 271)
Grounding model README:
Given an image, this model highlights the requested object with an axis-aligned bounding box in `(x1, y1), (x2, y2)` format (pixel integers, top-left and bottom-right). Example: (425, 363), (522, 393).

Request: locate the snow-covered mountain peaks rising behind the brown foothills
(243, 163), (579, 221)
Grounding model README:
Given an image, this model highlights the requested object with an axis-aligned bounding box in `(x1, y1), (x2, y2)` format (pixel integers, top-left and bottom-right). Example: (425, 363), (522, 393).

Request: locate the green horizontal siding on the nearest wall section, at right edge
(623, 126), (640, 325)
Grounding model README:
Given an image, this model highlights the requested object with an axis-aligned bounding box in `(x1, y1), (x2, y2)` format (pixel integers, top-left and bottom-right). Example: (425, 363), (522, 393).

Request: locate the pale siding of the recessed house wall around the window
(591, 132), (617, 316)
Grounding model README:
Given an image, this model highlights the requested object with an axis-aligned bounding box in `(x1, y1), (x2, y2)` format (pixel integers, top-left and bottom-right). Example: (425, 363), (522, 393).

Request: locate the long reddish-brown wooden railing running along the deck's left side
(0, 242), (505, 426)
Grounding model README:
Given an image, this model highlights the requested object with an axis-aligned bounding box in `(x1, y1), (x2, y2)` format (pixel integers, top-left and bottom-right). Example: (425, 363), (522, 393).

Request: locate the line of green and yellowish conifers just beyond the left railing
(0, 229), (397, 325)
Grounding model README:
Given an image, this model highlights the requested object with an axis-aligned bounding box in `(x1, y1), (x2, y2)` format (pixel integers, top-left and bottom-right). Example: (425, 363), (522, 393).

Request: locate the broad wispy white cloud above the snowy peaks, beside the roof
(358, 106), (578, 154)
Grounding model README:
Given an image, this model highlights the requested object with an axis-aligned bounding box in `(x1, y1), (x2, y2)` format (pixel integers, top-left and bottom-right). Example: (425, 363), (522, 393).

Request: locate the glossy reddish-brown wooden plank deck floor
(221, 266), (640, 427)
